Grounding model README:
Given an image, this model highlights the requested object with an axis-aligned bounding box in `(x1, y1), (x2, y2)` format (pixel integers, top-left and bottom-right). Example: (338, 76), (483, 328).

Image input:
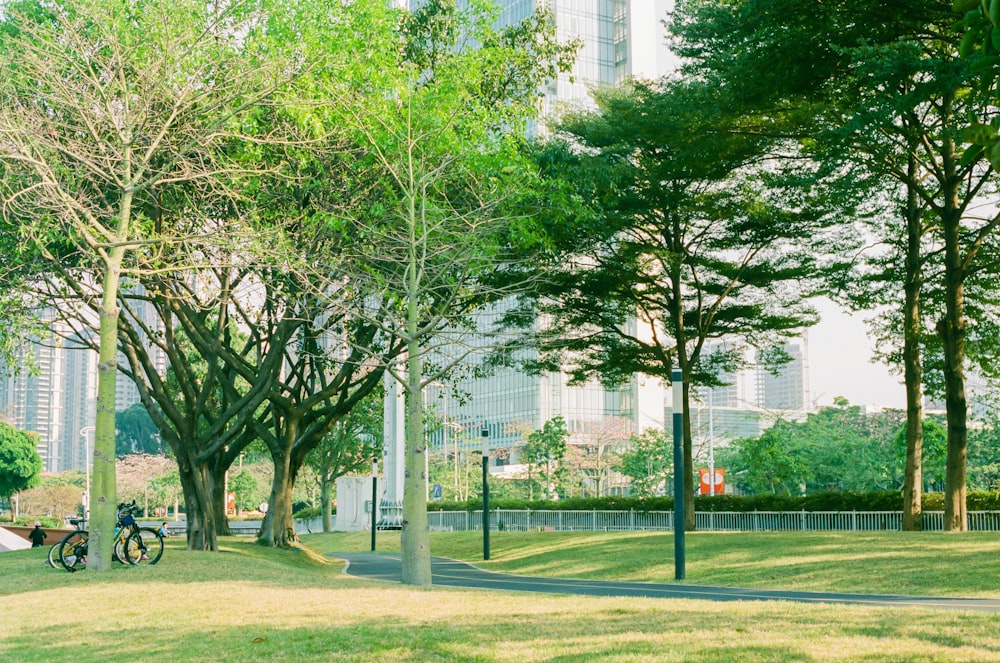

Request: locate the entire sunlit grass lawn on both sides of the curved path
(0, 532), (1000, 663)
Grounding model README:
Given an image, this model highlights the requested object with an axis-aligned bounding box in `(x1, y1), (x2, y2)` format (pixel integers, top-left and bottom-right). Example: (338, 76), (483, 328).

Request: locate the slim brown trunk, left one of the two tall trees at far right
(903, 172), (924, 532)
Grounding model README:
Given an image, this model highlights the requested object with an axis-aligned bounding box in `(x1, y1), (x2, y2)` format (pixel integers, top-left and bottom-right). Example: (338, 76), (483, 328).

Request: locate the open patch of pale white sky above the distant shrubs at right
(809, 299), (906, 408)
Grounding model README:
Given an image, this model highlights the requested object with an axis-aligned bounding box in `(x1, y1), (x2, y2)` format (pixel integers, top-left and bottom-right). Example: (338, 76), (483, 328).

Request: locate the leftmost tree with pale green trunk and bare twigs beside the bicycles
(0, 0), (301, 571)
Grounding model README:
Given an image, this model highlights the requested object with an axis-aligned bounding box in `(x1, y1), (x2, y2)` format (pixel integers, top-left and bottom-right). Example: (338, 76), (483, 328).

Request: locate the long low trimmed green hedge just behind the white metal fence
(438, 491), (1000, 512)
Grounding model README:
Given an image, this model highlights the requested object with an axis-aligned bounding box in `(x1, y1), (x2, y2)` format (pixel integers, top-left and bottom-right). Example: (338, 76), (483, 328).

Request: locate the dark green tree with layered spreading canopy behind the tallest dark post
(517, 79), (847, 529)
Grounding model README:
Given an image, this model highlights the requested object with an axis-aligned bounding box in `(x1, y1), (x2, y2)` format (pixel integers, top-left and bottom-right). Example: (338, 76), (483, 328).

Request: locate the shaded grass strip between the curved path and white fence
(304, 532), (1000, 599)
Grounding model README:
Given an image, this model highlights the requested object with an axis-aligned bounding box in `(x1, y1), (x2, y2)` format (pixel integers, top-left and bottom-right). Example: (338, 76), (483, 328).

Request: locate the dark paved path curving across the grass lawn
(327, 553), (1000, 612)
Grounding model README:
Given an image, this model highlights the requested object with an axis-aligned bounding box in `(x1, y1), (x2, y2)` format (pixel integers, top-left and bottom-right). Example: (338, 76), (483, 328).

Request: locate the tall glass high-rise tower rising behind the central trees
(413, 0), (673, 456)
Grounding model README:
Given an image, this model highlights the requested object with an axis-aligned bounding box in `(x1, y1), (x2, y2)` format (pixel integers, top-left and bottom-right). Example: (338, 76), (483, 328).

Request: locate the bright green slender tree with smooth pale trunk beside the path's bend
(329, 0), (580, 585)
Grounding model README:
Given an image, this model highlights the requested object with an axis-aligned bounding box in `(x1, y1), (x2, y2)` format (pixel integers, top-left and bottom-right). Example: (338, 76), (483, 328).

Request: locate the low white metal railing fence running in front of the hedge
(427, 509), (1000, 532)
